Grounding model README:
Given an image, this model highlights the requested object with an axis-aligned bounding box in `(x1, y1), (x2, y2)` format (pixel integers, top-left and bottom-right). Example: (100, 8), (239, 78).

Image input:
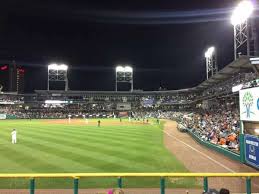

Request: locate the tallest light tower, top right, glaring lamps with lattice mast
(231, 0), (257, 60)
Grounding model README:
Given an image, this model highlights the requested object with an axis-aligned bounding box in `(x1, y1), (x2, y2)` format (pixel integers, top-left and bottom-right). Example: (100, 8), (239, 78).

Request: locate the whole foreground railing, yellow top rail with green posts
(0, 173), (259, 194)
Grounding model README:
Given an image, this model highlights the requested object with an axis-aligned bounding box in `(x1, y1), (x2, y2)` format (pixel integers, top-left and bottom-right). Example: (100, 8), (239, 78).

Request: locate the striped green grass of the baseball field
(0, 119), (197, 188)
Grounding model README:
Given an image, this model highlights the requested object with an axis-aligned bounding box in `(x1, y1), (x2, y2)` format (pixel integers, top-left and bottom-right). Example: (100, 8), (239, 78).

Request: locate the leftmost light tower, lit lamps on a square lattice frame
(48, 63), (68, 91)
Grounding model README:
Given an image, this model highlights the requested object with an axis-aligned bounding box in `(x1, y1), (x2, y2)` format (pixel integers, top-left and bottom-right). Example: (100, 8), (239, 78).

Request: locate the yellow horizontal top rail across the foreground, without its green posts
(0, 173), (259, 178)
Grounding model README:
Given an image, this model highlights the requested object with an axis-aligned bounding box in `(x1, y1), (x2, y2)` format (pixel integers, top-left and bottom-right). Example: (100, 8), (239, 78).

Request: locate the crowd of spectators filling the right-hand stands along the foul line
(134, 98), (240, 151)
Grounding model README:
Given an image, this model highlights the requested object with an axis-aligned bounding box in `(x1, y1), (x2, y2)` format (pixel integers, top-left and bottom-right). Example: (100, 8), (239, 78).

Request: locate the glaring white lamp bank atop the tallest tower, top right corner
(231, 1), (254, 26)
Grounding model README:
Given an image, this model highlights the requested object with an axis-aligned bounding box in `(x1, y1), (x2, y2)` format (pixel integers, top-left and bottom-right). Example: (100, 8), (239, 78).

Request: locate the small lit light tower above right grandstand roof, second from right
(205, 47), (218, 79)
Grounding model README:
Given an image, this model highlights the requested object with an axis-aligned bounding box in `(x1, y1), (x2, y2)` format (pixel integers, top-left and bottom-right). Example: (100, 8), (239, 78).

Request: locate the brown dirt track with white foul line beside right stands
(164, 120), (259, 193)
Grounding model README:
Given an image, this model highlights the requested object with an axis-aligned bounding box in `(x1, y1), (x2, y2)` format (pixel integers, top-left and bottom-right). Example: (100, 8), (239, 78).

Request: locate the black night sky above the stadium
(0, 0), (258, 91)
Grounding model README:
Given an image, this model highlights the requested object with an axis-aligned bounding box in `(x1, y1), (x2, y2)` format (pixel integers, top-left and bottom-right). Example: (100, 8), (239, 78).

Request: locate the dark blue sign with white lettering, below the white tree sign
(245, 135), (259, 168)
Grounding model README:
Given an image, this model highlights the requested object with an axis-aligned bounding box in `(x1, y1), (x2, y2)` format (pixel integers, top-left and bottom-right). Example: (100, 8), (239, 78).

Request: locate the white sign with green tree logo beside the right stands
(239, 87), (259, 121)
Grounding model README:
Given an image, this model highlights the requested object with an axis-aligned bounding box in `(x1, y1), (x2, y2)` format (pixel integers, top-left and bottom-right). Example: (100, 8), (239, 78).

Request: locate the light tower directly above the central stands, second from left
(115, 65), (133, 92)
